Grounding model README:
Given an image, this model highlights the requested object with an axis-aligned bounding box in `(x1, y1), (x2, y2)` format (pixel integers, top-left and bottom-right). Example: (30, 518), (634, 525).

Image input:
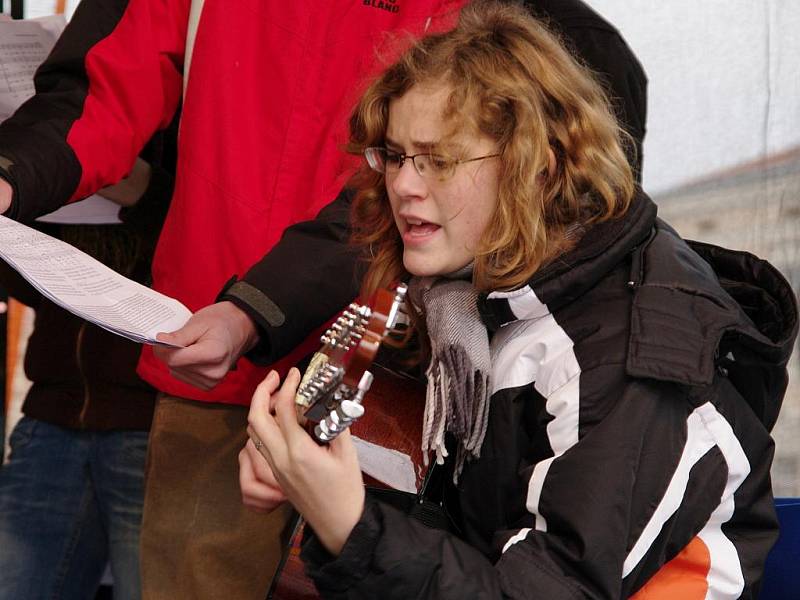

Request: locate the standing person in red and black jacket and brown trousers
(0, 0), (646, 598)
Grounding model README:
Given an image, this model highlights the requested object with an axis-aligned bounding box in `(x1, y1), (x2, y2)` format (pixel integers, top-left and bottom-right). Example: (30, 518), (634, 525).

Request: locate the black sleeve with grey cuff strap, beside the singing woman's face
(217, 189), (360, 364)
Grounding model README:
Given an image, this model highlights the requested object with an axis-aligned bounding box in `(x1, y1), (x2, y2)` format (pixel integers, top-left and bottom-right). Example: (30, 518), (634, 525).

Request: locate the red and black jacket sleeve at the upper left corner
(0, 0), (189, 221)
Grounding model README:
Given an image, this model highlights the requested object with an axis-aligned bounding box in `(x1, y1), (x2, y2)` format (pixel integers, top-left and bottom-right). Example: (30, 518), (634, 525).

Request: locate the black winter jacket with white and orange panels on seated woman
(303, 194), (797, 600)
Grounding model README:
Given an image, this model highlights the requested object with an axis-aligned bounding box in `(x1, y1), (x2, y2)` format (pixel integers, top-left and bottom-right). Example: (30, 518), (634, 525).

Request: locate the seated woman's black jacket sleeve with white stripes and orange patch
(303, 372), (776, 600)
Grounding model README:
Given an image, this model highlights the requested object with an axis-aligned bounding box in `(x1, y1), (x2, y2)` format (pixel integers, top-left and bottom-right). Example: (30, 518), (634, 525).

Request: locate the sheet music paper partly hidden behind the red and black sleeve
(0, 15), (120, 225)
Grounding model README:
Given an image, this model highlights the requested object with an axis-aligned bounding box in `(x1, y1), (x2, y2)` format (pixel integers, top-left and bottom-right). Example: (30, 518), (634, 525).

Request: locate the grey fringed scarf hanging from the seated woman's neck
(409, 265), (491, 481)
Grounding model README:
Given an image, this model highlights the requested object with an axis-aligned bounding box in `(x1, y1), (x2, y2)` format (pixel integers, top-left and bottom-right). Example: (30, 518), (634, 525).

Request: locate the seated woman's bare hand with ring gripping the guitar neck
(239, 369), (364, 555)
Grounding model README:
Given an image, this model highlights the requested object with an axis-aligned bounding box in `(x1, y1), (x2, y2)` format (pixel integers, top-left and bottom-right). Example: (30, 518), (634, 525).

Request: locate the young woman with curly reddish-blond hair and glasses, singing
(240, 4), (797, 600)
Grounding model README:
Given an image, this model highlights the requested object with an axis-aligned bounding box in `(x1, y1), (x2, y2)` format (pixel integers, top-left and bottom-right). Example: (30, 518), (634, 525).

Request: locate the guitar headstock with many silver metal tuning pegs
(295, 283), (408, 442)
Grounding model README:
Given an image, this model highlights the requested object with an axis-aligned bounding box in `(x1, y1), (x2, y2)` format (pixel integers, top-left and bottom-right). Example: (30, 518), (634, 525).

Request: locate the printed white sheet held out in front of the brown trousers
(0, 216), (192, 345)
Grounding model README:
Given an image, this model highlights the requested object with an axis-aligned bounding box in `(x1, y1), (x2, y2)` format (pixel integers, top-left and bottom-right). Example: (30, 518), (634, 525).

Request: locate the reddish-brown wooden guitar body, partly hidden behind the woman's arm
(267, 364), (425, 600)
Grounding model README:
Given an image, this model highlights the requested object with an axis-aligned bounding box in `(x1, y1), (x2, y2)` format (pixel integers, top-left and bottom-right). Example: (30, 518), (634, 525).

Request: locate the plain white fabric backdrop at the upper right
(588, 0), (800, 194)
